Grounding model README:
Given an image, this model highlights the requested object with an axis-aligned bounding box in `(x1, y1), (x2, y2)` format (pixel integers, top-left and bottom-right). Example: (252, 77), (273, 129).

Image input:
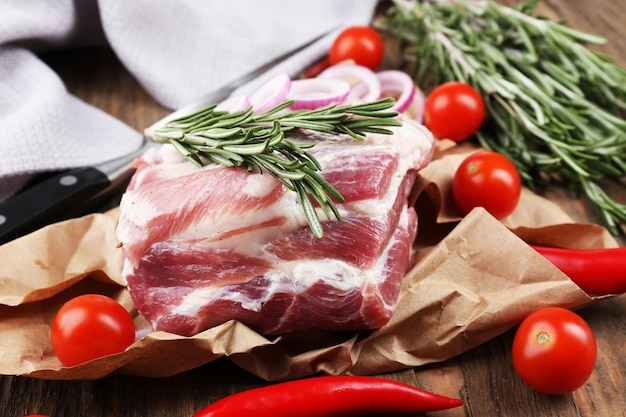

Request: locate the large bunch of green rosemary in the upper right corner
(385, 0), (626, 235)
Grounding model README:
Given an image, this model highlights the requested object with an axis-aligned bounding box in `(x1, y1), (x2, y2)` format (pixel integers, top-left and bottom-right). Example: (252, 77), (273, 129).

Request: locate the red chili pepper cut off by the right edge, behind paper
(533, 246), (626, 295)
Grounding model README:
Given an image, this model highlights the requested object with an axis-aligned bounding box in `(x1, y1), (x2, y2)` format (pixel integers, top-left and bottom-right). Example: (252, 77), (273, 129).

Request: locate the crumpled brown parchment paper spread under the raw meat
(0, 143), (617, 381)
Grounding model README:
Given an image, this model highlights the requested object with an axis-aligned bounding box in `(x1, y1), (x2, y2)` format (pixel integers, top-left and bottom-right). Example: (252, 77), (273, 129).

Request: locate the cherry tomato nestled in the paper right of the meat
(452, 151), (522, 219)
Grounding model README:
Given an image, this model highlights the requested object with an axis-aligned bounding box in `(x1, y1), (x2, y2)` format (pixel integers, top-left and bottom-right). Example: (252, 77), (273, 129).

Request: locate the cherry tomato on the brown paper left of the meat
(50, 294), (135, 366)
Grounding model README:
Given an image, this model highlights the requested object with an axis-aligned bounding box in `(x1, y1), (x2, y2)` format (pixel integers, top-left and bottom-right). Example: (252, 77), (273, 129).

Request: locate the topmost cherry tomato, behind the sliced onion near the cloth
(328, 26), (385, 71)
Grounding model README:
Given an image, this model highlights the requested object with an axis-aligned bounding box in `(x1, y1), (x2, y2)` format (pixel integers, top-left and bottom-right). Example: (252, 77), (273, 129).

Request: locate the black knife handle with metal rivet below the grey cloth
(0, 167), (111, 245)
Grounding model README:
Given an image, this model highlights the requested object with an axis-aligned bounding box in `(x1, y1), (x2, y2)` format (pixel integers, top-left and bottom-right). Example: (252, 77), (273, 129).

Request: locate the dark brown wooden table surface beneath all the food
(0, 0), (626, 417)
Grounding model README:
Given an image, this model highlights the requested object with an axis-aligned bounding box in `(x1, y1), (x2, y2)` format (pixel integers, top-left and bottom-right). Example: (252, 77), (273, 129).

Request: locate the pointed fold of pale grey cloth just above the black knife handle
(0, 47), (142, 197)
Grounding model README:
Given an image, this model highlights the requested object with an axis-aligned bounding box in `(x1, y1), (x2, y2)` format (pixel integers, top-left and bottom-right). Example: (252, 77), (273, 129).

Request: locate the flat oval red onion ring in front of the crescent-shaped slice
(287, 78), (350, 110)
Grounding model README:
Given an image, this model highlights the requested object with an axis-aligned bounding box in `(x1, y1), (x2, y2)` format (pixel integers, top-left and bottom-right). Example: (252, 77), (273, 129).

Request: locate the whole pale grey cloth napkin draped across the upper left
(0, 0), (377, 201)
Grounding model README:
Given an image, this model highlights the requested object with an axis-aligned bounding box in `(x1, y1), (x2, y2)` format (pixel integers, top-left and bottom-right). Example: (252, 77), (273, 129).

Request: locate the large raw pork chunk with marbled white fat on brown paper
(117, 115), (433, 336)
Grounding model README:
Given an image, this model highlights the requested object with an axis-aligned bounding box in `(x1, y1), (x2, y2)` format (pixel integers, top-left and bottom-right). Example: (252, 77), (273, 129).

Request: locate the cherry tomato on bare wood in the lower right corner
(513, 307), (597, 395)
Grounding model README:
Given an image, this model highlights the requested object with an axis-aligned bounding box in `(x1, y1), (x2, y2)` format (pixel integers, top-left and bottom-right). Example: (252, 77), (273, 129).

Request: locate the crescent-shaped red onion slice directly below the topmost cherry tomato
(317, 64), (380, 102)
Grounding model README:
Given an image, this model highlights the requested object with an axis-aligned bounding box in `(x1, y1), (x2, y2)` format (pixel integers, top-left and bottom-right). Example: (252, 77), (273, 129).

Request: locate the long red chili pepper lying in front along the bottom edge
(193, 376), (463, 417)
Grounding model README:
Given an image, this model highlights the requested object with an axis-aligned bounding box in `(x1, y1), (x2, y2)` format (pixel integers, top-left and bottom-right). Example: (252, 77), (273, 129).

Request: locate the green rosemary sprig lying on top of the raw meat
(152, 98), (401, 238)
